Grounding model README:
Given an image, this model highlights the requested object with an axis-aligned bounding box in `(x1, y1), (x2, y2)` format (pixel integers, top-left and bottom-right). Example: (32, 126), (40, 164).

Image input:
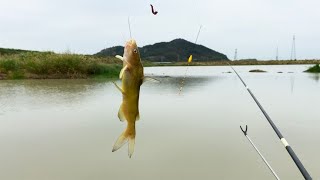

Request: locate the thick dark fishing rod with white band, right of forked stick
(227, 62), (312, 180)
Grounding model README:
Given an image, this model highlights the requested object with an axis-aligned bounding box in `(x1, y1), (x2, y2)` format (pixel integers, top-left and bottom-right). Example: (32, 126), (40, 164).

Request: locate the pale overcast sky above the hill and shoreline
(0, 0), (320, 59)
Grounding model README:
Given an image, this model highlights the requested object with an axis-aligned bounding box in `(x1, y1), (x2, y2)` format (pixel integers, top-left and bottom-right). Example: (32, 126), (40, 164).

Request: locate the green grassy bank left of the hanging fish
(0, 52), (122, 79)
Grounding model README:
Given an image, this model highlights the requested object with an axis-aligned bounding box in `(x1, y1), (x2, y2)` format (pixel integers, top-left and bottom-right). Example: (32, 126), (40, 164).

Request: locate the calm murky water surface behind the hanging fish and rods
(0, 65), (320, 180)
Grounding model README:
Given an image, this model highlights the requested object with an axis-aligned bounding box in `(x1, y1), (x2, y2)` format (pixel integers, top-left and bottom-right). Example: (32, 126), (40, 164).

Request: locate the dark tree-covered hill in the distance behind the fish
(95, 39), (228, 62)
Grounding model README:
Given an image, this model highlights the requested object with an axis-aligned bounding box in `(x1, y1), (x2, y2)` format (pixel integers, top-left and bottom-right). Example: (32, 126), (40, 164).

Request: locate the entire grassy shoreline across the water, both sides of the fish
(0, 52), (320, 80)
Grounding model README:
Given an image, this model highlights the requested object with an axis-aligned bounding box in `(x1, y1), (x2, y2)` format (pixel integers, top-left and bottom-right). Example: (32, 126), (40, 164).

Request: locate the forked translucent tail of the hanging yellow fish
(112, 124), (136, 158)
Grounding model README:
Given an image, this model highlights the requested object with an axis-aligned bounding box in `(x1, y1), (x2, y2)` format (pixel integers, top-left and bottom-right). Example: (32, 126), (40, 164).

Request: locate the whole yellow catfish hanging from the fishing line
(112, 39), (144, 157)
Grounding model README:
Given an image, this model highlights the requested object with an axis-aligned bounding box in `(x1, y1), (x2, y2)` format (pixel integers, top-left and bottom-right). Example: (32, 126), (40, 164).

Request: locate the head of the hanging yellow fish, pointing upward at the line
(123, 39), (141, 65)
